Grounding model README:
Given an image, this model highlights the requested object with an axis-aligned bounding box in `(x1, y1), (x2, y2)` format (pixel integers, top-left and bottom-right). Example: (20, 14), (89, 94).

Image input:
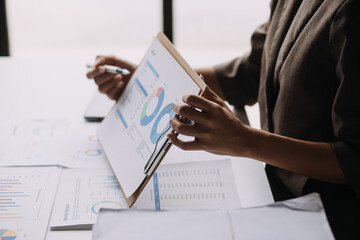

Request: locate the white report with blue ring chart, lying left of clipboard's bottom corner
(50, 169), (128, 229)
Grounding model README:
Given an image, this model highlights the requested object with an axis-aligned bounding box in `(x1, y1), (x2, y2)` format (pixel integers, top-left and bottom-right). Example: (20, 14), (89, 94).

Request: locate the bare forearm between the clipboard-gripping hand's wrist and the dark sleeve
(244, 128), (346, 183)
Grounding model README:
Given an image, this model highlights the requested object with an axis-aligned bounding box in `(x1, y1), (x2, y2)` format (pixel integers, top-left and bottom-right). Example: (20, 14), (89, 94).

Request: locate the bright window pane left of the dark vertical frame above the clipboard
(7, 0), (162, 58)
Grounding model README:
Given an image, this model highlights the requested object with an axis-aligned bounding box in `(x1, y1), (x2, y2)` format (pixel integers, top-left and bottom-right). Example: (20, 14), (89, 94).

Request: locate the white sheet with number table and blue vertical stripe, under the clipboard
(133, 159), (241, 210)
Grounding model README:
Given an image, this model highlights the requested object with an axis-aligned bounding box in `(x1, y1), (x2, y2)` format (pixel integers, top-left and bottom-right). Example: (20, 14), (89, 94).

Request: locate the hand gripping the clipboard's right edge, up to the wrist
(168, 88), (249, 156)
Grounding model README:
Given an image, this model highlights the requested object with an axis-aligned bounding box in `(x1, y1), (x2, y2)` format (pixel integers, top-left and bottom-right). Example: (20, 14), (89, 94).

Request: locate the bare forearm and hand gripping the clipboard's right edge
(168, 79), (347, 184)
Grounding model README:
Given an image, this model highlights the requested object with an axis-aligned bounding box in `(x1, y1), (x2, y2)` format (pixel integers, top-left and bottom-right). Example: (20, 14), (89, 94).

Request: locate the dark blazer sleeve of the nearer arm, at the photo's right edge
(329, 0), (360, 196)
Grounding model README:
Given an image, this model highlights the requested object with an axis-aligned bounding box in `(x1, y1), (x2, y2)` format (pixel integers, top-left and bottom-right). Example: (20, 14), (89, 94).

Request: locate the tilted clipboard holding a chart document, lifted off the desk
(98, 33), (206, 207)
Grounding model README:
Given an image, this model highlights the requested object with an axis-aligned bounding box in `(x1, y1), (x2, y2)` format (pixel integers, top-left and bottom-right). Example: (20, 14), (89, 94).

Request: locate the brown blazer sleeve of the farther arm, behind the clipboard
(215, 24), (267, 106)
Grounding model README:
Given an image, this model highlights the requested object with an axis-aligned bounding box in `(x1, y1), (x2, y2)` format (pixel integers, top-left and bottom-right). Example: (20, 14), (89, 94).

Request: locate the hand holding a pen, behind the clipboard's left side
(86, 56), (137, 100)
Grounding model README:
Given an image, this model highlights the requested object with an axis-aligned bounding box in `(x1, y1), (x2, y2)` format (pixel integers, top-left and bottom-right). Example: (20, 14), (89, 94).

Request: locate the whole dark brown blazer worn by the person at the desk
(215, 0), (360, 236)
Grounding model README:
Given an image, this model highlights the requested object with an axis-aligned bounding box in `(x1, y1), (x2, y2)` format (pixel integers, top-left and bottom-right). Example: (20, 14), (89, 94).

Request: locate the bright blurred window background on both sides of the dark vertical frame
(2, 0), (270, 66)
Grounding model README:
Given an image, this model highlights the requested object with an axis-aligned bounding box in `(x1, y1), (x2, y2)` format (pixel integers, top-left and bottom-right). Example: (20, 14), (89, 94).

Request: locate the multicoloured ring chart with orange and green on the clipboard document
(140, 87), (165, 126)
